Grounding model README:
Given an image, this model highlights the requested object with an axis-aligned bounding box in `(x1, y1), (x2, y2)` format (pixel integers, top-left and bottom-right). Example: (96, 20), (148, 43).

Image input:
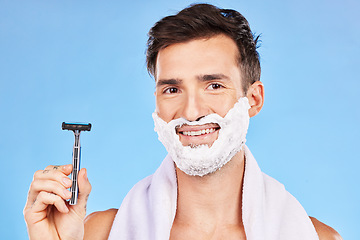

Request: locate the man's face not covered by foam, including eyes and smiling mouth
(155, 35), (243, 146)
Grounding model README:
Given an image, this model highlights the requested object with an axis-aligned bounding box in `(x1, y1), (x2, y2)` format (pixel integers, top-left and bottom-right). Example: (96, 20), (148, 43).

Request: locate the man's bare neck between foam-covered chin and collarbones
(175, 151), (245, 229)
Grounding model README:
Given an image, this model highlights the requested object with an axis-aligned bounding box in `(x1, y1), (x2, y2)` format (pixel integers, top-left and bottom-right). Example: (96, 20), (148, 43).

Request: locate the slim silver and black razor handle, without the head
(69, 130), (81, 205)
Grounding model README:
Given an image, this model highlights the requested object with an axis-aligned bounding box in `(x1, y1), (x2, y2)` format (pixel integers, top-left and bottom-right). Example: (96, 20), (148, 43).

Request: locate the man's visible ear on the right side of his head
(246, 81), (264, 117)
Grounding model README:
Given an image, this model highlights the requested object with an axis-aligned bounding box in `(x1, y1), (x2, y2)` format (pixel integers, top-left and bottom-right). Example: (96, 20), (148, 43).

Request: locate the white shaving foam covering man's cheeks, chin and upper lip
(152, 97), (250, 176)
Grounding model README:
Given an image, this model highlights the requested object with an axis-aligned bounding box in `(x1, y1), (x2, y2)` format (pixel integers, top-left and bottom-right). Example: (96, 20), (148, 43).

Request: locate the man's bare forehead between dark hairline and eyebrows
(155, 35), (239, 79)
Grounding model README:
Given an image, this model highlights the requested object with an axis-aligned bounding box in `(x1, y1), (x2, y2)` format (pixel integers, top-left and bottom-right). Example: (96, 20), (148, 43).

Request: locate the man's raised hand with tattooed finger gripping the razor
(24, 164), (91, 240)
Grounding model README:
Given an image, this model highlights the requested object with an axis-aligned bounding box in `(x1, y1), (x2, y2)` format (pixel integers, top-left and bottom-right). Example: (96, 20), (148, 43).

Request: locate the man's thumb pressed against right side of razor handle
(72, 168), (91, 217)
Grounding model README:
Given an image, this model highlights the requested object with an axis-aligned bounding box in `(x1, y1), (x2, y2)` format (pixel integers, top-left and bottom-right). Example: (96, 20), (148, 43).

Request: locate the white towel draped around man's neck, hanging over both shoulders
(109, 146), (319, 240)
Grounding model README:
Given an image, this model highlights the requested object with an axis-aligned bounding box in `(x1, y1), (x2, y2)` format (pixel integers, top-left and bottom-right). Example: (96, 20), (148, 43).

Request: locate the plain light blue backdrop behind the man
(0, 0), (360, 239)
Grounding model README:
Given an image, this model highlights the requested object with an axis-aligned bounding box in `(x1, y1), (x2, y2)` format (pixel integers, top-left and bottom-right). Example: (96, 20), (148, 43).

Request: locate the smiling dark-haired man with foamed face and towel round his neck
(24, 4), (341, 240)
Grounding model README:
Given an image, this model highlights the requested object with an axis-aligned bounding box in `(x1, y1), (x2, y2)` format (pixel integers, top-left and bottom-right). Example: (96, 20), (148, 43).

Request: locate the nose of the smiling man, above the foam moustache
(181, 93), (207, 121)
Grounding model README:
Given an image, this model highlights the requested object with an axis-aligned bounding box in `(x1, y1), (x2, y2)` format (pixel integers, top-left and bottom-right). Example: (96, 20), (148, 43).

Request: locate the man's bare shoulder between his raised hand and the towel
(84, 208), (118, 240)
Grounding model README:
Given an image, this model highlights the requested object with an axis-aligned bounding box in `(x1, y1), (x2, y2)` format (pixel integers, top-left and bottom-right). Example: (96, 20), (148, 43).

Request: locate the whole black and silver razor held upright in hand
(62, 122), (91, 205)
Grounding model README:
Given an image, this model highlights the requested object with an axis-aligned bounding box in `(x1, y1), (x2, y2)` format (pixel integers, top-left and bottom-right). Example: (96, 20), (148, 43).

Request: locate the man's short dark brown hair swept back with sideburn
(146, 4), (261, 93)
